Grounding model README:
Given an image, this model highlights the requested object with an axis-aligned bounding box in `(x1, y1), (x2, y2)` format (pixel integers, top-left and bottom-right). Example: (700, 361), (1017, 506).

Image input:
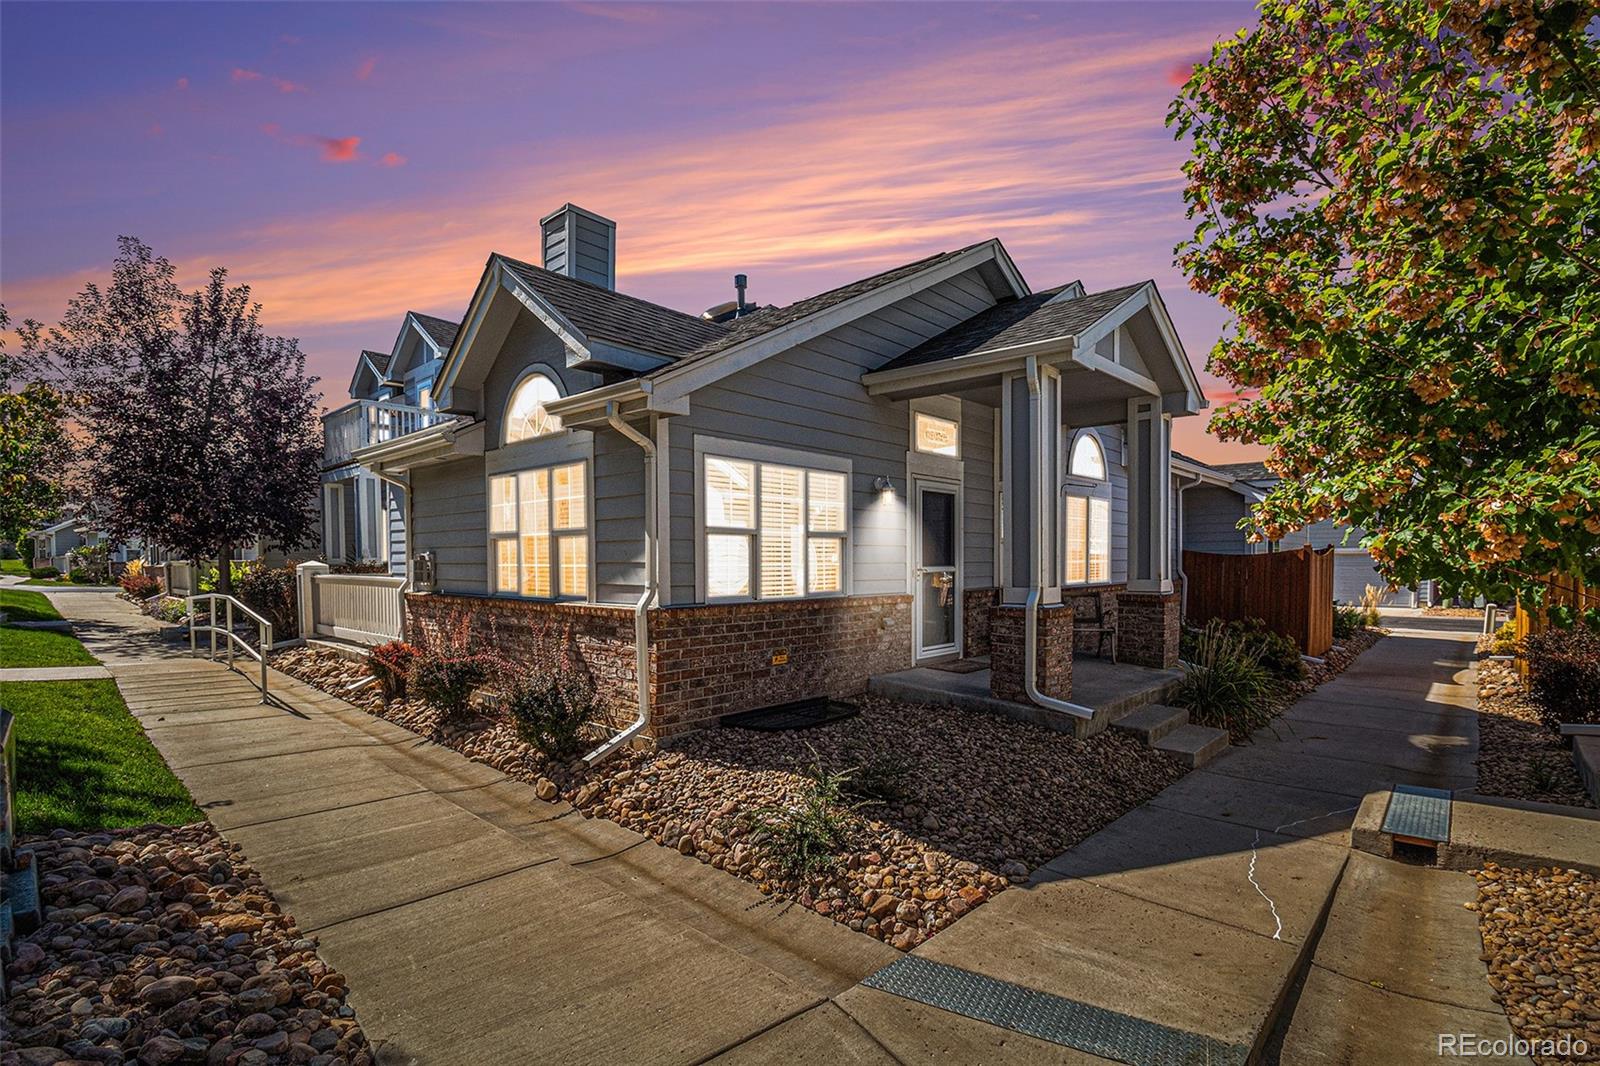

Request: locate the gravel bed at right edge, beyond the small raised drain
(1478, 659), (1594, 807)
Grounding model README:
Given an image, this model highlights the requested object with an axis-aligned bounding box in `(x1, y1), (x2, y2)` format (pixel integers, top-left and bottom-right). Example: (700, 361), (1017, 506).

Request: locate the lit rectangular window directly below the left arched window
(490, 463), (589, 599)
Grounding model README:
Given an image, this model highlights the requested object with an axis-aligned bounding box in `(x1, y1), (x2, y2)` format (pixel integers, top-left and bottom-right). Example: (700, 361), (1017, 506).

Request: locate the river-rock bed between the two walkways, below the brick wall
(274, 648), (1184, 949)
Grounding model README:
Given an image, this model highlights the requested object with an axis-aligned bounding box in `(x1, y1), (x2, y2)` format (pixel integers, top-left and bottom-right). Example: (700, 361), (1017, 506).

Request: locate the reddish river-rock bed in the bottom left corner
(0, 823), (373, 1066)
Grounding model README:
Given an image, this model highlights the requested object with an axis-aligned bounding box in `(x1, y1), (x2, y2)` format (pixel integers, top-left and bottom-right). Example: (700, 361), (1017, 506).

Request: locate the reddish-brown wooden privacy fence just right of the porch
(1184, 547), (1333, 655)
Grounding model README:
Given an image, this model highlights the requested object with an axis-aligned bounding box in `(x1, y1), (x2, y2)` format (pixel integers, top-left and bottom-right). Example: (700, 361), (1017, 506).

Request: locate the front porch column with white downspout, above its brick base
(1000, 367), (1061, 605)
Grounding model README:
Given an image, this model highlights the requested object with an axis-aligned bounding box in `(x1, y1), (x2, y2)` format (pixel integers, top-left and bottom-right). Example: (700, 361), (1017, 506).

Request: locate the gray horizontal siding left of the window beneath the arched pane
(411, 458), (488, 594)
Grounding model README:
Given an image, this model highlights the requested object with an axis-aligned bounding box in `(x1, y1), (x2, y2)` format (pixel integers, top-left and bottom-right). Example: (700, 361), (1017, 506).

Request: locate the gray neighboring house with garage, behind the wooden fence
(1173, 455), (1416, 607)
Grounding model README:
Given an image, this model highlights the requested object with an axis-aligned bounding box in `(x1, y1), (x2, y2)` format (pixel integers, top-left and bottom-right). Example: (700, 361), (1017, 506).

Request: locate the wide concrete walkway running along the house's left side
(59, 595), (896, 1066)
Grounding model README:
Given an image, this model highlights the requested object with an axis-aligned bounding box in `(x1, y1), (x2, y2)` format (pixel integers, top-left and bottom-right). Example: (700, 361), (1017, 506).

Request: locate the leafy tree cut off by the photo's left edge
(0, 307), (67, 541)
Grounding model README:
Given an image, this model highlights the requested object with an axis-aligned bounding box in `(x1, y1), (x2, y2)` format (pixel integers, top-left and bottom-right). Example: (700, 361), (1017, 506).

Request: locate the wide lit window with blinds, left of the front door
(701, 455), (850, 600)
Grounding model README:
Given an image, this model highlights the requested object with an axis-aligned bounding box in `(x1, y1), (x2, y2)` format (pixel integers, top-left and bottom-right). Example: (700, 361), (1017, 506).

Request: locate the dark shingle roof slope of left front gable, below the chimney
(499, 256), (728, 359)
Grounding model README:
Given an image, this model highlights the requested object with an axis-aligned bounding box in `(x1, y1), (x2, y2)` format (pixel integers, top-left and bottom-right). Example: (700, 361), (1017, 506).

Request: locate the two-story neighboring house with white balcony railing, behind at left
(322, 311), (456, 576)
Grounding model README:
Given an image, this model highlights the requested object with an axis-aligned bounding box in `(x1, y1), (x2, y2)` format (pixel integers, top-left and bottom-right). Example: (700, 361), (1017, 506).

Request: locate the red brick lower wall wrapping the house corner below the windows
(406, 594), (912, 739)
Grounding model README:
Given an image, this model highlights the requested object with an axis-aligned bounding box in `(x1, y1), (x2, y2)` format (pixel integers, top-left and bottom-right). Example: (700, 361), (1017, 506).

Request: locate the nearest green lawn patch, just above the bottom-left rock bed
(0, 680), (203, 832)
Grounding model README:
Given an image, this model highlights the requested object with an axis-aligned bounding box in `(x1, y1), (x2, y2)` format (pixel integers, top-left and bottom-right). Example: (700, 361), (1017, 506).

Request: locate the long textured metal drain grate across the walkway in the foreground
(862, 956), (1250, 1066)
